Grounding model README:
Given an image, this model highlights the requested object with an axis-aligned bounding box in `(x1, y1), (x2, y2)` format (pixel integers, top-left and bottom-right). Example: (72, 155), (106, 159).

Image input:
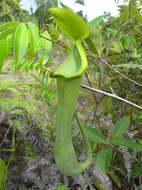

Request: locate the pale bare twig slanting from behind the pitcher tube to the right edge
(81, 84), (142, 110)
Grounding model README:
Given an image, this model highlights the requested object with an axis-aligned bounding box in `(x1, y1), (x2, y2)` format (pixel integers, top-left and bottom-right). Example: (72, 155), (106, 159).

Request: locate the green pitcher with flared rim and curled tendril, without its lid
(53, 41), (92, 176)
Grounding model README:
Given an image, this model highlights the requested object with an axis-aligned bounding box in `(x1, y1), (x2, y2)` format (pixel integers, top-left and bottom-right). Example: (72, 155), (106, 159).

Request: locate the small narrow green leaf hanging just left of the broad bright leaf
(5, 34), (13, 59)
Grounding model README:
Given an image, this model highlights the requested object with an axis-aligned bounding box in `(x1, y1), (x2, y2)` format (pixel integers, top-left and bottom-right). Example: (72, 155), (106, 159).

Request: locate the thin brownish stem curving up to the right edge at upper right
(105, 12), (142, 58)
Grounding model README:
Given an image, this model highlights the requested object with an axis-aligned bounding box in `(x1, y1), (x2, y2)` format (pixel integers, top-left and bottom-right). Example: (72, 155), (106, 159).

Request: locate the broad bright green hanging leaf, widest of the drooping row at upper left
(14, 23), (29, 64)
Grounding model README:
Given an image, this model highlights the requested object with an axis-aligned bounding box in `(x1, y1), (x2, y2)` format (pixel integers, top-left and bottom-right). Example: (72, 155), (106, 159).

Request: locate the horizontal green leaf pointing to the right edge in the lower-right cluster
(112, 138), (142, 151)
